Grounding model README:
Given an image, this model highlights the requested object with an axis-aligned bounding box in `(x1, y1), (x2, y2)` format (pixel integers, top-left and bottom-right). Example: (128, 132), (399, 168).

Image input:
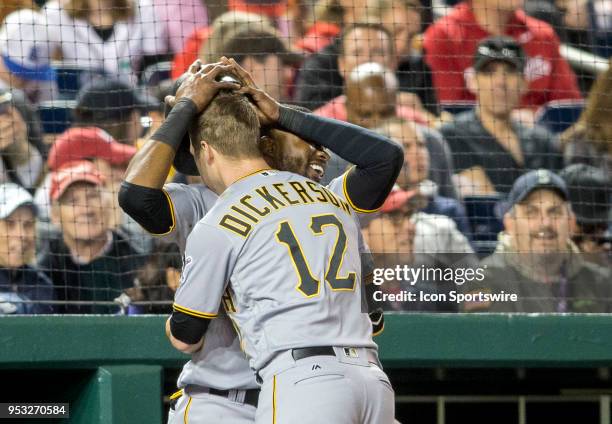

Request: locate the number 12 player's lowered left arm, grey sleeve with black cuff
(166, 222), (236, 353)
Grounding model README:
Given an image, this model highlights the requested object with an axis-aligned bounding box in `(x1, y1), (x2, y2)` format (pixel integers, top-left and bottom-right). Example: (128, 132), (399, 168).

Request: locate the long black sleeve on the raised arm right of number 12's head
(278, 106), (404, 211)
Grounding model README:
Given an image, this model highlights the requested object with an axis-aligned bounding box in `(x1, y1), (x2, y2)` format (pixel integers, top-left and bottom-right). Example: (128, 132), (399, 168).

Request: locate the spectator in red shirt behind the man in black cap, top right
(424, 0), (581, 114)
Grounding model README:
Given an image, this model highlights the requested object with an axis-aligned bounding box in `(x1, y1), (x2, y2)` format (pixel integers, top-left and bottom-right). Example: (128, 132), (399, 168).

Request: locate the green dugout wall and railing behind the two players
(0, 314), (612, 424)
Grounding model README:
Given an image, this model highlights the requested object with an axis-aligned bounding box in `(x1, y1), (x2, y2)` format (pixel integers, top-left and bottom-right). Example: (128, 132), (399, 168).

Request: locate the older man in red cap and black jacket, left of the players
(38, 161), (143, 313)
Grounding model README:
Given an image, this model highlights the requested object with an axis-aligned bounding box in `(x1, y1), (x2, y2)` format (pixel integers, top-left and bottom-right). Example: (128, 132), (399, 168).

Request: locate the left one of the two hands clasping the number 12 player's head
(165, 59), (240, 112)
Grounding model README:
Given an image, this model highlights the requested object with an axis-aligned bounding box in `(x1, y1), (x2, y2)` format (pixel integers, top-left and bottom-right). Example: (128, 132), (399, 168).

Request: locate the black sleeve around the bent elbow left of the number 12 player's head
(119, 181), (174, 235)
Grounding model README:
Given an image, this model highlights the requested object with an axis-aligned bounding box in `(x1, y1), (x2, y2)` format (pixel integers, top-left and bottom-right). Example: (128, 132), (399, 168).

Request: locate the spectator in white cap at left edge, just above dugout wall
(0, 183), (54, 315)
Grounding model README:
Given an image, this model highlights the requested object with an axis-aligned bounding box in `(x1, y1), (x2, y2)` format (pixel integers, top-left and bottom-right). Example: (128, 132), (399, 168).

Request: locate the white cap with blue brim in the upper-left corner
(0, 9), (56, 81)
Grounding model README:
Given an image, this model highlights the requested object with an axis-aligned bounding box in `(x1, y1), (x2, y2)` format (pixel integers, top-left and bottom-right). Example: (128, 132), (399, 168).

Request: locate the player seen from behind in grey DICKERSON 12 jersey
(166, 58), (403, 423)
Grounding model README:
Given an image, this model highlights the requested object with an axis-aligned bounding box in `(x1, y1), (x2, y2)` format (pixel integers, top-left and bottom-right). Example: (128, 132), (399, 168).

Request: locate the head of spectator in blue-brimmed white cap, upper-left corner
(0, 9), (57, 103)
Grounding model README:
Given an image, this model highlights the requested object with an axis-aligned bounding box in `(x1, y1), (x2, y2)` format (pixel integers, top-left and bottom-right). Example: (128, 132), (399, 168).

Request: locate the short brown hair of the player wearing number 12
(189, 90), (261, 158)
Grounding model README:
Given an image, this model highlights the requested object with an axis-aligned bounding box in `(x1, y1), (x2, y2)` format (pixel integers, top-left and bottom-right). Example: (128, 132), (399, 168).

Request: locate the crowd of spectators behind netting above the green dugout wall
(0, 0), (612, 314)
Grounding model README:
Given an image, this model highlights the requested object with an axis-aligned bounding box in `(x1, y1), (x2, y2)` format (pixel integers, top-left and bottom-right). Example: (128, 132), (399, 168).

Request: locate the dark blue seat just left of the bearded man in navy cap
(463, 195), (503, 256)
